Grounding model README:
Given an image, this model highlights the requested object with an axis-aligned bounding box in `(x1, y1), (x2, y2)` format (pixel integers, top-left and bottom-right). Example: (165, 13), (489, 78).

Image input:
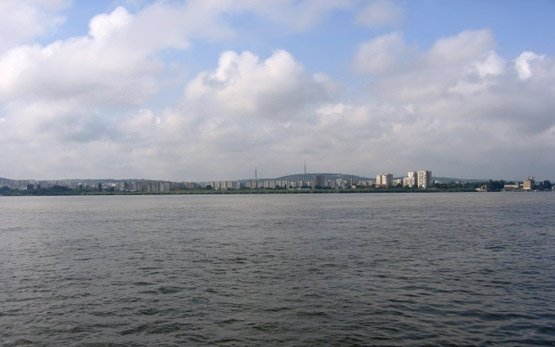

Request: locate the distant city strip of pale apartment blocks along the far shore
(0, 170), (555, 195)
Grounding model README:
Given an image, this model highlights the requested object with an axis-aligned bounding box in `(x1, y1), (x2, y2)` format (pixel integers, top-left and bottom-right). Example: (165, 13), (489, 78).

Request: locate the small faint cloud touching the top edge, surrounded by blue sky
(355, 0), (404, 27)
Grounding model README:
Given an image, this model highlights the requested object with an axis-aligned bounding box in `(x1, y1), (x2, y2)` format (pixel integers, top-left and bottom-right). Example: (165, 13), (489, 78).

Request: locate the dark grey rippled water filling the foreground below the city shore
(0, 193), (555, 346)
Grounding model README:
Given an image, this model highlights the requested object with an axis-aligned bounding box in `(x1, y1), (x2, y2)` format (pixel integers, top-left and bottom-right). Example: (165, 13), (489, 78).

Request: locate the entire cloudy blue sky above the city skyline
(0, 0), (555, 181)
